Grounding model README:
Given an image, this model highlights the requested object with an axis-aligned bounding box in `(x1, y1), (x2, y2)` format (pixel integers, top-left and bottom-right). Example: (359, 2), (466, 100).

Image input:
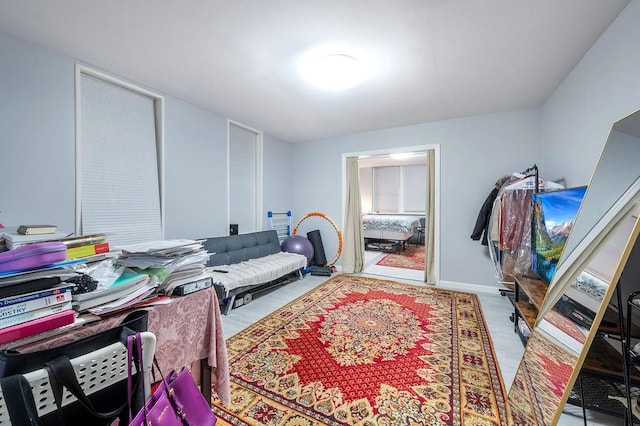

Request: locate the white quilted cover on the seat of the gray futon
(207, 252), (307, 296)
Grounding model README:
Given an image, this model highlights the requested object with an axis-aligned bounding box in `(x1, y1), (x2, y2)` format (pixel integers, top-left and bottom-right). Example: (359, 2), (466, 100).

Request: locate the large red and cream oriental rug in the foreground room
(213, 274), (507, 426)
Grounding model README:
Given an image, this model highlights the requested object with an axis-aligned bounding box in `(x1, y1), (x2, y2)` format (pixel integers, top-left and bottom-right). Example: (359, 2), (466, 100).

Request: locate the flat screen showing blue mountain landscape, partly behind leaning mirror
(531, 186), (587, 284)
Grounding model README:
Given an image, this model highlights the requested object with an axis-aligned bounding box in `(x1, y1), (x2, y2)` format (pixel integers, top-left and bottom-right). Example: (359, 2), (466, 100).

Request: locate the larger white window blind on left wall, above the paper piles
(79, 73), (163, 247)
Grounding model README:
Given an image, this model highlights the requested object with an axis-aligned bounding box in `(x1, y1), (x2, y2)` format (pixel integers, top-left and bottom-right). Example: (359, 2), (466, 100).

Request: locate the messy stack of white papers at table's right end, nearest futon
(118, 240), (210, 295)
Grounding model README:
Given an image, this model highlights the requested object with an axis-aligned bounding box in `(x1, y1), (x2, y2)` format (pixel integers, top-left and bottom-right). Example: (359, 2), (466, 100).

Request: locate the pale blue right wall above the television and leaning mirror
(541, 1), (640, 186)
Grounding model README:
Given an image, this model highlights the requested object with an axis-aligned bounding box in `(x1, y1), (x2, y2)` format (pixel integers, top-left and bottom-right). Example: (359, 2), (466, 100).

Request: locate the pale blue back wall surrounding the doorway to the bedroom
(292, 110), (540, 287)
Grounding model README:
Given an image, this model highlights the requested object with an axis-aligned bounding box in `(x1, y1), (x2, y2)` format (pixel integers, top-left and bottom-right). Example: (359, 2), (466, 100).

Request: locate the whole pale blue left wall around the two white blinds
(0, 33), (291, 238)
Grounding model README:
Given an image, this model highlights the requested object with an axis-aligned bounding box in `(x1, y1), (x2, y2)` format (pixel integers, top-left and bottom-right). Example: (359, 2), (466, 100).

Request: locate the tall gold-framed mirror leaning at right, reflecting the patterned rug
(508, 112), (640, 425)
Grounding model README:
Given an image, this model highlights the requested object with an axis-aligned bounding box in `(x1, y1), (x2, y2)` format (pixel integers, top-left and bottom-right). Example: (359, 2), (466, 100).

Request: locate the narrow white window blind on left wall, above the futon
(229, 124), (258, 234)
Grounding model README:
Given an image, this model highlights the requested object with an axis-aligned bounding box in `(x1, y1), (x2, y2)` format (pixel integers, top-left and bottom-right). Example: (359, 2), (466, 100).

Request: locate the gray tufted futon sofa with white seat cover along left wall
(204, 230), (307, 315)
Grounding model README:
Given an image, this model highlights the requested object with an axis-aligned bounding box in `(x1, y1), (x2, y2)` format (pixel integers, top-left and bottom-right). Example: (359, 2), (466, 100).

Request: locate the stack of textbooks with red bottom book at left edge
(0, 278), (76, 344)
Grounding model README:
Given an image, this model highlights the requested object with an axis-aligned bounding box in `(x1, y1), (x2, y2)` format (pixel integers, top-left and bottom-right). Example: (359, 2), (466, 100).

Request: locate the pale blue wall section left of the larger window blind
(0, 34), (75, 232)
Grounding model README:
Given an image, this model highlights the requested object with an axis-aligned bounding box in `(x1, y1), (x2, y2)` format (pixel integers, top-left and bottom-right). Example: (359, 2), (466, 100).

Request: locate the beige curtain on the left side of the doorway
(342, 157), (364, 273)
